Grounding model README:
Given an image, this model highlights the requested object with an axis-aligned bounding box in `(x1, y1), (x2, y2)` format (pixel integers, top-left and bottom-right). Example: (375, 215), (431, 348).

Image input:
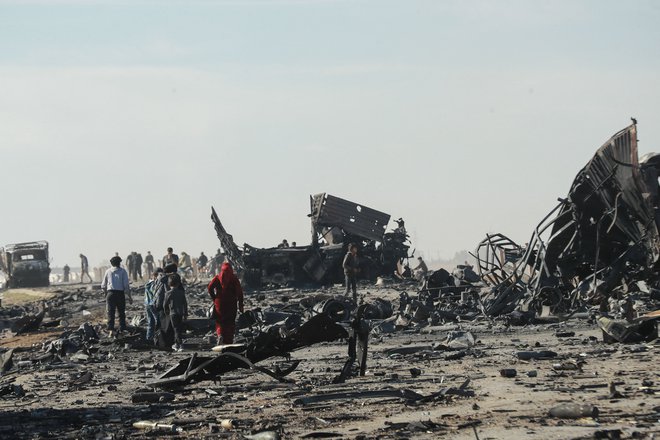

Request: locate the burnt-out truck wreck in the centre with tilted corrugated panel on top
(211, 193), (411, 289)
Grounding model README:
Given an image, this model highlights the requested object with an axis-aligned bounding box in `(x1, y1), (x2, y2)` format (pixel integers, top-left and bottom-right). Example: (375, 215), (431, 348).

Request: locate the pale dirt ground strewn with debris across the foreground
(0, 285), (660, 440)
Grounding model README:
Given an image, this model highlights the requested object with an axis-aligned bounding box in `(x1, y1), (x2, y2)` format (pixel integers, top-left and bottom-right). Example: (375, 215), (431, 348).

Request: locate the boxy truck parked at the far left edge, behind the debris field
(0, 241), (50, 288)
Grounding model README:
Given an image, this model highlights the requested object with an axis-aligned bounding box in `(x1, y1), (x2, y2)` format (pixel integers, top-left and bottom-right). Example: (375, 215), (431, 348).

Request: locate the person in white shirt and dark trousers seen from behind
(101, 257), (133, 337)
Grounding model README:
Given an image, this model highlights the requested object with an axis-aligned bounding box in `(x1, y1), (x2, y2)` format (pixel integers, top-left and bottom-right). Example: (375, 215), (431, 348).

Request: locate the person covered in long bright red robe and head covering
(208, 263), (243, 344)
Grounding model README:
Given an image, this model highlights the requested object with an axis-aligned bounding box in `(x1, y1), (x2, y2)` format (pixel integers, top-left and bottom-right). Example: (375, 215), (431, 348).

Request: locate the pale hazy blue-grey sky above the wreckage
(0, 0), (660, 265)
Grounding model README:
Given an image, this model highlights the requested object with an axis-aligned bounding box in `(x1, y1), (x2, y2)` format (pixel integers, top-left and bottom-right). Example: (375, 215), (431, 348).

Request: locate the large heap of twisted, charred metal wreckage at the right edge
(473, 120), (660, 316)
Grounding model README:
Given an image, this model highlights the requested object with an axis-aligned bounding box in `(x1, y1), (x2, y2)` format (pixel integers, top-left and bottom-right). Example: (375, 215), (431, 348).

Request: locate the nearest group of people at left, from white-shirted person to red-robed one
(101, 248), (243, 351)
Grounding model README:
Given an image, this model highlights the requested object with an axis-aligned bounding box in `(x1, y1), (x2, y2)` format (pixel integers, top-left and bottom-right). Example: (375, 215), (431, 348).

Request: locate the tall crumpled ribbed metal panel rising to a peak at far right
(557, 124), (659, 269)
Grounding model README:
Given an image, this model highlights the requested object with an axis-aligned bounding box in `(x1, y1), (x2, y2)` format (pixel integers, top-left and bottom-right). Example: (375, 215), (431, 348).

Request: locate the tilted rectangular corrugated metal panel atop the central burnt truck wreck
(311, 193), (390, 240)
